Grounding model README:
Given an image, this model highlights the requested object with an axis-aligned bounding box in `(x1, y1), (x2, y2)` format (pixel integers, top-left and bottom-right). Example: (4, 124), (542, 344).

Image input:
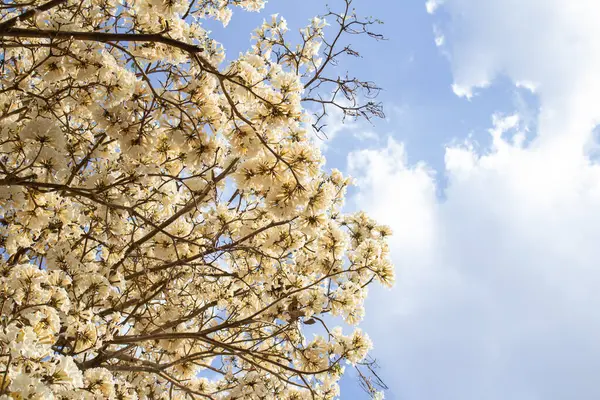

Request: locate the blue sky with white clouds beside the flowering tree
(215, 0), (600, 400)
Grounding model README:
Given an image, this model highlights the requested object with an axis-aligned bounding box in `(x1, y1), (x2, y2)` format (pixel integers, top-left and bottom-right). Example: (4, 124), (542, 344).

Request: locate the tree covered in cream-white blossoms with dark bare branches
(0, 0), (393, 399)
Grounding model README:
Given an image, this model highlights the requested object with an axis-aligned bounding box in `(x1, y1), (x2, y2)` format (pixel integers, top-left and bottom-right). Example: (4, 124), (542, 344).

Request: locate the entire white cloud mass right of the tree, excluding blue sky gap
(348, 0), (600, 400)
